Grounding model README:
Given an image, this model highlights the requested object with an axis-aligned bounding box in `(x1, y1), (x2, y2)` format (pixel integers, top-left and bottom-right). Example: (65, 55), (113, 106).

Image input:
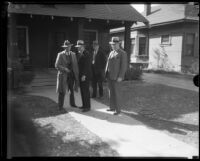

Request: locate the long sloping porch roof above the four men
(8, 4), (148, 23)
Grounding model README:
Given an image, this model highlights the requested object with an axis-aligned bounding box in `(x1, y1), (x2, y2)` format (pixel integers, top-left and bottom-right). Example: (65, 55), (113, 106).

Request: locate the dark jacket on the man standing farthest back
(92, 49), (106, 74)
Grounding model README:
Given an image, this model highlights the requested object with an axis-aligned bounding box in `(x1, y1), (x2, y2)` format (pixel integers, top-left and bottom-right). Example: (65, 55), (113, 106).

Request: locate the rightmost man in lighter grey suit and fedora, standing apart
(105, 37), (127, 115)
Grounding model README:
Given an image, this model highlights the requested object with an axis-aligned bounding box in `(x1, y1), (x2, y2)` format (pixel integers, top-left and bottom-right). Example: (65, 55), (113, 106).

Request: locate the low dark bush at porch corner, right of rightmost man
(125, 64), (142, 80)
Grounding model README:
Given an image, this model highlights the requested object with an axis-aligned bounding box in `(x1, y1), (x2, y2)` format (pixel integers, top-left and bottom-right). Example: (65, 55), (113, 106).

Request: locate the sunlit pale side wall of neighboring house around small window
(148, 24), (184, 72)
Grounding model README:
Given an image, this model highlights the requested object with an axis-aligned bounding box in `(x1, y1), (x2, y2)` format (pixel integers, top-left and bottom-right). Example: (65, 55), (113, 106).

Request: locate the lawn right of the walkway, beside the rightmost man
(96, 81), (199, 147)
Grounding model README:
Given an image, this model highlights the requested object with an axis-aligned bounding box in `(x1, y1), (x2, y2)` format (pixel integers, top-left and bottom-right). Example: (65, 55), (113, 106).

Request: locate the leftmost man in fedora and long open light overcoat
(55, 40), (79, 110)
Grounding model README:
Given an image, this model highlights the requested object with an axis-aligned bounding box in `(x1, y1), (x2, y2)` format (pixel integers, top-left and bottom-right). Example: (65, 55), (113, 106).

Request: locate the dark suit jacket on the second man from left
(78, 50), (92, 80)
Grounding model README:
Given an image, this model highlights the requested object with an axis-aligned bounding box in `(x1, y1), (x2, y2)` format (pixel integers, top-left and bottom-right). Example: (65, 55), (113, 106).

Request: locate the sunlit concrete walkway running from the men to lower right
(30, 87), (199, 158)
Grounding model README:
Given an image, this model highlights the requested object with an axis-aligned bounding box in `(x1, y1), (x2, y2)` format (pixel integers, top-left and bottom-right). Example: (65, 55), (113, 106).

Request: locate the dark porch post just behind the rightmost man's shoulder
(124, 21), (133, 68)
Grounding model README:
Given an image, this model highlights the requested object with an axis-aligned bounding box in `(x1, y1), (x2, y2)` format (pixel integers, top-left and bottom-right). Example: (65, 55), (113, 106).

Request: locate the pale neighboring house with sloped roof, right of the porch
(111, 4), (199, 73)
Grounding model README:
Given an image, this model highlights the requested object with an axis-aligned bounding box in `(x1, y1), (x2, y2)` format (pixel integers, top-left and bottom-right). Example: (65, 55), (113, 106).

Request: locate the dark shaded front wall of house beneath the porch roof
(17, 14), (110, 68)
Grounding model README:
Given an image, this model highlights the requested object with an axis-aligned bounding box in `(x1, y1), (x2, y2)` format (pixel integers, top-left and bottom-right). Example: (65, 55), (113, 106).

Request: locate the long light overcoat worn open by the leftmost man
(55, 51), (79, 93)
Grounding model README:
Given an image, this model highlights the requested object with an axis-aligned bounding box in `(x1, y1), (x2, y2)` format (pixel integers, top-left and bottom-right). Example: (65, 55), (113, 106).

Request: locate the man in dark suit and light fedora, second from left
(75, 40), (91, 112)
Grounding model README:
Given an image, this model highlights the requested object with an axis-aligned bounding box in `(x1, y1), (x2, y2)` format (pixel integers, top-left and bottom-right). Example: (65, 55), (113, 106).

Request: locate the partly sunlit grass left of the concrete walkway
(8, 94), (118, 156)
